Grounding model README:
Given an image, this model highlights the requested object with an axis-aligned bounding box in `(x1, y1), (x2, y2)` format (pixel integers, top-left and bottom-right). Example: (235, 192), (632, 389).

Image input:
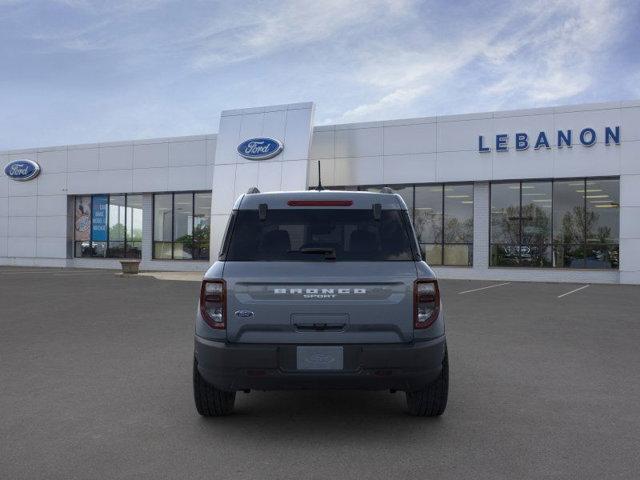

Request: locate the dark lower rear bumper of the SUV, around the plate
(195, 335), (445, 391)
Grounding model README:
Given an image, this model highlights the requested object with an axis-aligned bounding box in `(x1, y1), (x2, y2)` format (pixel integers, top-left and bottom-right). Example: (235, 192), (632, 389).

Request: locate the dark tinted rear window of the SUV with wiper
(225, 208), (413, 261)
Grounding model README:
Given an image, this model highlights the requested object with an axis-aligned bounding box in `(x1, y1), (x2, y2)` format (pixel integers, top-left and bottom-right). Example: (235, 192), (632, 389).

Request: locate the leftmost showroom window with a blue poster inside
(74, 194), (142, 258)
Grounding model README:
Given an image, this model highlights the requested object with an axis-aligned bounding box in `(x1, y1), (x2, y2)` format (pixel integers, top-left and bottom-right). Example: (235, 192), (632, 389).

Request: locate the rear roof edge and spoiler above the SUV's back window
(233, 190), (407, 210)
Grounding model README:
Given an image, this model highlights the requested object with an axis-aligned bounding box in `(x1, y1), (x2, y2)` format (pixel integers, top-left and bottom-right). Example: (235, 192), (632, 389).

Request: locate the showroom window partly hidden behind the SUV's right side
(331, 183), (473, 266)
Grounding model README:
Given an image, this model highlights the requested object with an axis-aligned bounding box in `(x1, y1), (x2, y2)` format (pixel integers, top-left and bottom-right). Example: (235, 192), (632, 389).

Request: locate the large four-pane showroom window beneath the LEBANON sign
(490, 178), (620, 269)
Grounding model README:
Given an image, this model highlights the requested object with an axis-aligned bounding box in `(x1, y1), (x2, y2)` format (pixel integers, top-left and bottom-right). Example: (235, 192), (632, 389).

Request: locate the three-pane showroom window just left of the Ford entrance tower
(153, 192), (211, 260)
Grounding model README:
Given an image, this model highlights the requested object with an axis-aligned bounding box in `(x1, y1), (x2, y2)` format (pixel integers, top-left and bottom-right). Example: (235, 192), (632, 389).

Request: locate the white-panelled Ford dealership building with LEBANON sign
(0, 101), (640, 284)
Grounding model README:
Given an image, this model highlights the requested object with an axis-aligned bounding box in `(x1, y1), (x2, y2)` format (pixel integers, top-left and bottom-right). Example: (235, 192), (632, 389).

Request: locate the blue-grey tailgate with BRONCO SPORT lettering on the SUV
(224, 262), (416, 344)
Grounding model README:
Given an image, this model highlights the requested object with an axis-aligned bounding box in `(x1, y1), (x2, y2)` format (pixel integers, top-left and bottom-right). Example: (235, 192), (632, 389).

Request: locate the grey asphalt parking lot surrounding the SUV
(0, 267), (640, 480)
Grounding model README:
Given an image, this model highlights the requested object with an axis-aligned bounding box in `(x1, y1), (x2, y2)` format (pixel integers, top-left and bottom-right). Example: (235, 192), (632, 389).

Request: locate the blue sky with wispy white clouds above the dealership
(0, 0), (640, 149)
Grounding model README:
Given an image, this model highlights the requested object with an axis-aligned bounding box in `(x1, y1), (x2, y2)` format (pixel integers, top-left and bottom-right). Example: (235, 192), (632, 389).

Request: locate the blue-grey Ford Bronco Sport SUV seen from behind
(193, 188), (449, 416)
